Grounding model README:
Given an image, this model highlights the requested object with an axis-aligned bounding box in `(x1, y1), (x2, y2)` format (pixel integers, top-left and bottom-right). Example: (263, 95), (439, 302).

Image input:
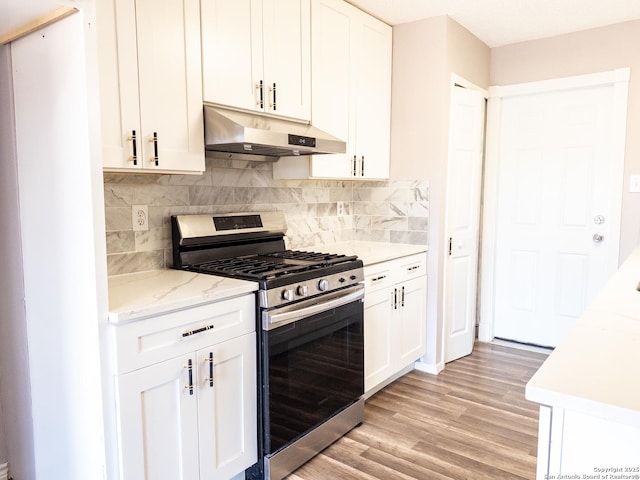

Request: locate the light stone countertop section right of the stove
(302, 241), (427, 267)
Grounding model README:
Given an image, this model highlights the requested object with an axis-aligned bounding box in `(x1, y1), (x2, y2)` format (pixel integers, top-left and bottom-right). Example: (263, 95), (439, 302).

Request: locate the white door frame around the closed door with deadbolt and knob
(478, 68), (630, 342)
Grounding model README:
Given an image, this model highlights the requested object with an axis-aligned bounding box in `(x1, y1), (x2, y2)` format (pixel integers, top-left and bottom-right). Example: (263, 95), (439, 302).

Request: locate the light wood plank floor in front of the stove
(287, 343), (546, 480)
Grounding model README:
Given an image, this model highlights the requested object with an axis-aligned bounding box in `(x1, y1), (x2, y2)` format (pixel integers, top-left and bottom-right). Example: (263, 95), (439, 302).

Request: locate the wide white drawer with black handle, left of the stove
(113, 295), (255, 374)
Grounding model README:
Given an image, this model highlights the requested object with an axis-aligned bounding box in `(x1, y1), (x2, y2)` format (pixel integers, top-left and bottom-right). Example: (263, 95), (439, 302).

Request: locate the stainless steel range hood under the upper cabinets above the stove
(204, 104), (347, 161)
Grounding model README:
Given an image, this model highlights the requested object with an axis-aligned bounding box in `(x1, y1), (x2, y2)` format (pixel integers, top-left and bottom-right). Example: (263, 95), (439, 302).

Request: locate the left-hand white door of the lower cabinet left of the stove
(117, 355), (199, 480)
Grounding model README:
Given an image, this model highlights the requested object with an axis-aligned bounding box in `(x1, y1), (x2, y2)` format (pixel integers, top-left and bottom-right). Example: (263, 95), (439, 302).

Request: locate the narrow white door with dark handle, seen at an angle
(444, 86), (485, 362)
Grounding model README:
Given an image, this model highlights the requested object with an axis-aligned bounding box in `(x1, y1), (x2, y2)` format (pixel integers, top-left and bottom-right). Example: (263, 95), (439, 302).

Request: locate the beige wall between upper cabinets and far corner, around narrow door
(391, 17), (490, 365)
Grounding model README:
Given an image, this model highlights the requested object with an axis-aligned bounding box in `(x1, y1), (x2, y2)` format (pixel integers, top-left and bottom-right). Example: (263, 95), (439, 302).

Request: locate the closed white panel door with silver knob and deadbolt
(494, 84), (622, 346)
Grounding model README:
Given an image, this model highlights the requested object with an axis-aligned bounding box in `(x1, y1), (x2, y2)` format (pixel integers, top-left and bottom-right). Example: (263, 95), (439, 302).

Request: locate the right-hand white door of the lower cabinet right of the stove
(396, 277), (427, 369)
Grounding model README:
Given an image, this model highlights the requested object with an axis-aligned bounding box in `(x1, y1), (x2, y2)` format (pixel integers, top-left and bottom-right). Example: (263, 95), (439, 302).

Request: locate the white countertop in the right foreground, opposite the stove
(526, 247), (640, 428)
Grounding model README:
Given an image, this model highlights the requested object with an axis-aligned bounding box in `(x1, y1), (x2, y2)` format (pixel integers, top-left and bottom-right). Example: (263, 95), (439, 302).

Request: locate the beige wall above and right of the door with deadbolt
(490, 20), (640, 262)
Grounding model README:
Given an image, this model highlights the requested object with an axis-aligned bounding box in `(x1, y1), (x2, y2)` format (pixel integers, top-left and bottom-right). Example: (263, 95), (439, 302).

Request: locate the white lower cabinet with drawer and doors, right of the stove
(364, 254), (427, 393)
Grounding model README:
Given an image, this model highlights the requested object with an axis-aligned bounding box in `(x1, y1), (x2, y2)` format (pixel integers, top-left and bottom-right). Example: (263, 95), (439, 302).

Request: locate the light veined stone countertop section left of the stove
(109, 269), (258, 323)
